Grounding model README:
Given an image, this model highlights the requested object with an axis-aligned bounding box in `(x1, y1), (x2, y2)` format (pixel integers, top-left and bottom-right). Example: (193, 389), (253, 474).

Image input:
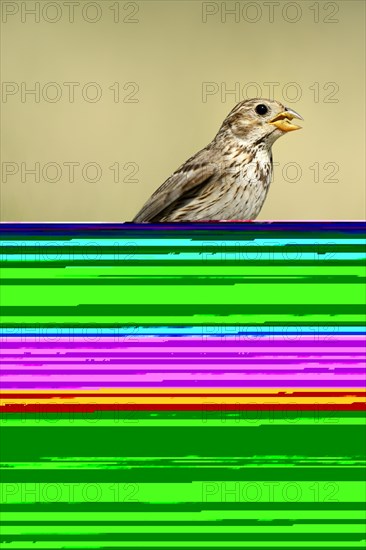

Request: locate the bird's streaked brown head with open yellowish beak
(221, 98), (303, 145)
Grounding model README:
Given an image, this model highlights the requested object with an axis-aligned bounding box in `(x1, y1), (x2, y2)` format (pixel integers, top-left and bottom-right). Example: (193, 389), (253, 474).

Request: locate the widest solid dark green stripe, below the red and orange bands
(0, 425), (366, 462)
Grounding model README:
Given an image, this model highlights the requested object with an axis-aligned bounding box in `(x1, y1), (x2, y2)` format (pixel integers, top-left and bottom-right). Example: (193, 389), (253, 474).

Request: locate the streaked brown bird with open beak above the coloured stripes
(132, 98), (303, 223)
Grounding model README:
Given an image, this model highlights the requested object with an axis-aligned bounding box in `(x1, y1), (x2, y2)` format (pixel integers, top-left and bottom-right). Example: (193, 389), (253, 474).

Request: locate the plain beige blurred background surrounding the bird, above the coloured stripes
(1, 0), (366, 221)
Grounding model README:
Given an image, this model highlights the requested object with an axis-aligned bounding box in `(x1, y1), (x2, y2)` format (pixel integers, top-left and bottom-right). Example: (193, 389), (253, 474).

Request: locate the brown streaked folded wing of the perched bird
(132, 155), (217, 223)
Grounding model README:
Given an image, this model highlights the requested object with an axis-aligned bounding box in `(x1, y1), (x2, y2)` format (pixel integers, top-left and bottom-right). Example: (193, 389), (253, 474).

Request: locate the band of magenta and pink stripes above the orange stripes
(1, 335), (366, 390)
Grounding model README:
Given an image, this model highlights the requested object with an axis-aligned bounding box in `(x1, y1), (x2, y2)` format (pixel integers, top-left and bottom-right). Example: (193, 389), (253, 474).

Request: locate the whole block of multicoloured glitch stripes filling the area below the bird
(0, 222), (366, 550)
